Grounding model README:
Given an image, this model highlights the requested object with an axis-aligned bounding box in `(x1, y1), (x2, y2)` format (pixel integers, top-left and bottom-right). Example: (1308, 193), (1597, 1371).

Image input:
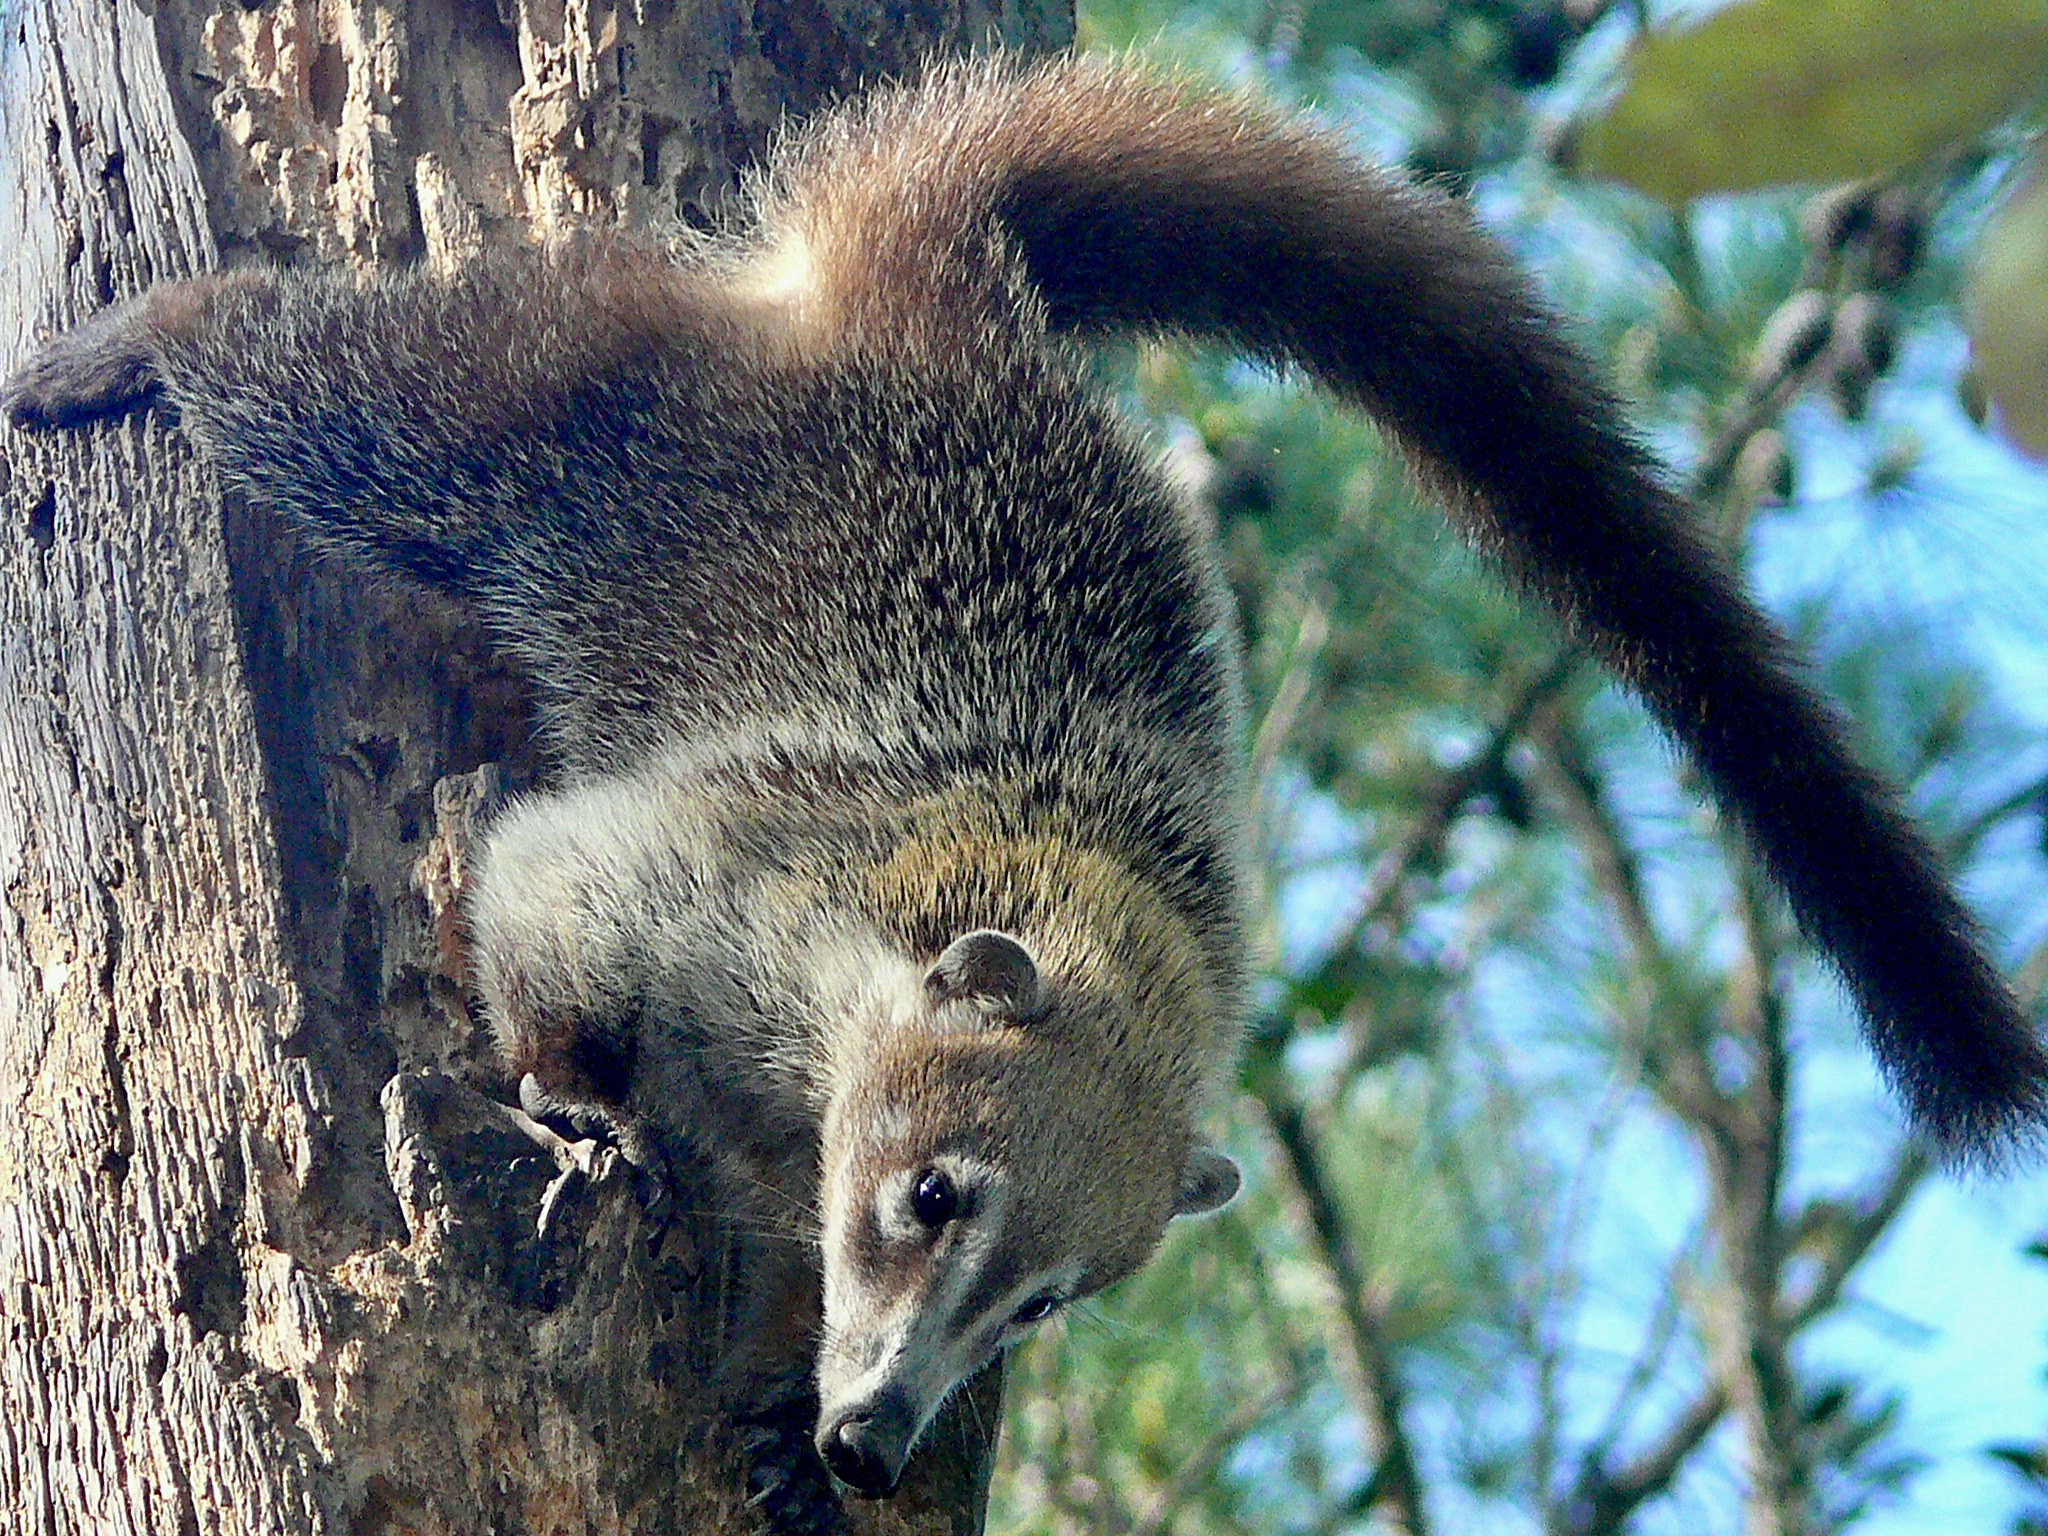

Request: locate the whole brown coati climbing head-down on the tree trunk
(6, 48), (2048, 1515)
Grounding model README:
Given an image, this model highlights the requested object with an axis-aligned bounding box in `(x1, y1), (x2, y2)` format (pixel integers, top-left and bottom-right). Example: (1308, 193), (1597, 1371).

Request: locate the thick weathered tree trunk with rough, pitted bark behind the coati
(0, 0), (1071, 1536)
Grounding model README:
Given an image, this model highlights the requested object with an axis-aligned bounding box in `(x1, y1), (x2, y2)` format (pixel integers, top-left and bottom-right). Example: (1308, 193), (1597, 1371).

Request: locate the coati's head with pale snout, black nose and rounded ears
(817, 930), (1239, 1497)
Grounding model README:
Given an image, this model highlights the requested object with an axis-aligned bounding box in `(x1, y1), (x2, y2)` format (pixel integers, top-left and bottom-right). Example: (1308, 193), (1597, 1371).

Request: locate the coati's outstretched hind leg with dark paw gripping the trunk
(0, 240), (720, 598)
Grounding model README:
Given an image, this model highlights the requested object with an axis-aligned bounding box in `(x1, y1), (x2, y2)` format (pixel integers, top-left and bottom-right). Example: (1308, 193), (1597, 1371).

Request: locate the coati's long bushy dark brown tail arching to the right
(760, 59), (2048, 1157)
